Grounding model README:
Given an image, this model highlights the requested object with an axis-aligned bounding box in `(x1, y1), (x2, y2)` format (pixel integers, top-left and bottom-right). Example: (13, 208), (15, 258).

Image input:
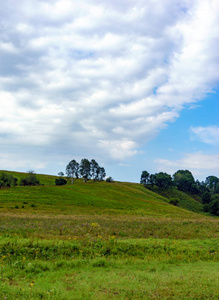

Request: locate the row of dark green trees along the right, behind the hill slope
(140, 170), (219, 216)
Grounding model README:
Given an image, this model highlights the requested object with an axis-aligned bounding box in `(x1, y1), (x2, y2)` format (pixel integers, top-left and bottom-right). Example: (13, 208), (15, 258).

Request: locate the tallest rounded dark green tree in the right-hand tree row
(173, 170), (195, 192)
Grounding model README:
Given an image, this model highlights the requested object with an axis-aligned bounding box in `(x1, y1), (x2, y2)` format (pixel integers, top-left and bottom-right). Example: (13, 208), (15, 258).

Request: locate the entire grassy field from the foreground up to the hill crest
(0, 173), (219, 299)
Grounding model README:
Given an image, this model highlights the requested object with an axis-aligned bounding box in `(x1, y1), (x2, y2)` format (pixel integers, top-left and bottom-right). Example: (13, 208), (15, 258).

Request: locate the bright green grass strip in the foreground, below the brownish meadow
(0, 238), (219, 299)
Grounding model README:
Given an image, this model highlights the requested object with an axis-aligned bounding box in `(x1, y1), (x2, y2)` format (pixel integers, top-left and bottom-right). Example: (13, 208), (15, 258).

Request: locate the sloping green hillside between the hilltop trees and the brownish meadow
(0, 172), (204, 218)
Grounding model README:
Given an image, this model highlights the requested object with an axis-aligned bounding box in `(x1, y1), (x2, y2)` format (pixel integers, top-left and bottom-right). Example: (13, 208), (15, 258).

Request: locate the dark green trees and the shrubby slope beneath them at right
(140, 170), (219, 216)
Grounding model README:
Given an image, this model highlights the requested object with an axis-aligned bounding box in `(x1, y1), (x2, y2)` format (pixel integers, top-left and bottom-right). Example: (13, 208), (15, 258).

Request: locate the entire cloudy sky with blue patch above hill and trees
(0, 0), (219, 182)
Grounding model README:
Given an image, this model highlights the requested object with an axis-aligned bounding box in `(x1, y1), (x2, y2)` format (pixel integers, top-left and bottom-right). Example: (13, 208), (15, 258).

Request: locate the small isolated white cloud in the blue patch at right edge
(190, 126), (219, 145)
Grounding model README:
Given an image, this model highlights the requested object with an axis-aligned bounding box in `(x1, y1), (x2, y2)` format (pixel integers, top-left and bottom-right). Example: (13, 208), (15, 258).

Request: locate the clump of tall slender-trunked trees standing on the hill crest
(66, 158), (106, 184)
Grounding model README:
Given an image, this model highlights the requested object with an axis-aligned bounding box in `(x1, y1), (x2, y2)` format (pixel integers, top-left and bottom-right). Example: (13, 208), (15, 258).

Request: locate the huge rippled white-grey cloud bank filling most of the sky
(0, 0), (219, 171)
